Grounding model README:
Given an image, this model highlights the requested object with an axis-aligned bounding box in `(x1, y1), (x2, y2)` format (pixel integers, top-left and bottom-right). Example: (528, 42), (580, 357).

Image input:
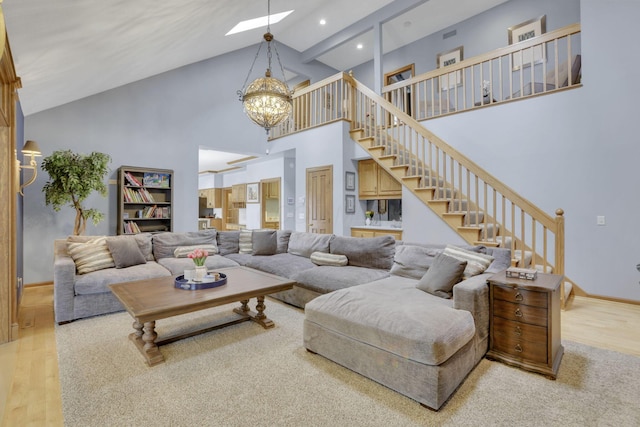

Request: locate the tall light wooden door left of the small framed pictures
(306, 166), (333, 234)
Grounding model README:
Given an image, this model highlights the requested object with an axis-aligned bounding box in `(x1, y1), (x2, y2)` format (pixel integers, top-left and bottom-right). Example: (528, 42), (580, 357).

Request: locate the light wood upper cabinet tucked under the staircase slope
(358, 159), (402, 200)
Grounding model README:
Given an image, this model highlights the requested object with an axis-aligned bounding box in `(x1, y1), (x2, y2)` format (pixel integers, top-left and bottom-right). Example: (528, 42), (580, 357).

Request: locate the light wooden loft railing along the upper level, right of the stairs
(382, 24), (581, 120)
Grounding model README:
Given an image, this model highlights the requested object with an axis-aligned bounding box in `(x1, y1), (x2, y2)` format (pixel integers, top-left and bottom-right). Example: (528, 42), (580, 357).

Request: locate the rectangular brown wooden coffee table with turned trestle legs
(109, 267), (295, 366)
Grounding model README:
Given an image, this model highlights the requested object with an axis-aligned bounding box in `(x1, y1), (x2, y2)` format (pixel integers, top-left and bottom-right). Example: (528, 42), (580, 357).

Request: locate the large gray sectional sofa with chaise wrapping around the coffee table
(54, 230), (511, 410)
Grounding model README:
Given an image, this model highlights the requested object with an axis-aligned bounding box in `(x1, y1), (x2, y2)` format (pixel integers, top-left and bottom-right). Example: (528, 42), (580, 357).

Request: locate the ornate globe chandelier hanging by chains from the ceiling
(237, 0), (292, 138)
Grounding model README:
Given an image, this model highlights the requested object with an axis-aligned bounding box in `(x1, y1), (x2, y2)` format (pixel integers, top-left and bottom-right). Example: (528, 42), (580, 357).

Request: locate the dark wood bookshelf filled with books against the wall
(116, 166), (175, 234)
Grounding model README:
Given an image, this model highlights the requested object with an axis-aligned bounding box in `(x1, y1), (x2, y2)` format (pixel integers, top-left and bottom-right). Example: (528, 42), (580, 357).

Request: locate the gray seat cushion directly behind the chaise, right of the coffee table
(291, 265), (389, 294)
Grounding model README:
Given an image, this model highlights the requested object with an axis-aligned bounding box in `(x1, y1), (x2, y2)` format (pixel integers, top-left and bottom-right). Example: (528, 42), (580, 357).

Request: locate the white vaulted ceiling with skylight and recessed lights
(2, 0), (506, 115)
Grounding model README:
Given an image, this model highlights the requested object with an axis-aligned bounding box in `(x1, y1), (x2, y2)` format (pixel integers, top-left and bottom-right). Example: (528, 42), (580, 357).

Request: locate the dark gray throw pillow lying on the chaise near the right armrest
(416, 253), (467, 299)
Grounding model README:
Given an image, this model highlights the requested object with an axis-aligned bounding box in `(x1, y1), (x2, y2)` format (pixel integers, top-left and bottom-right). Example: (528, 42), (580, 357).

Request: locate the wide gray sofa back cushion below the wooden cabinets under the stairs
(329, 236), (396, 270)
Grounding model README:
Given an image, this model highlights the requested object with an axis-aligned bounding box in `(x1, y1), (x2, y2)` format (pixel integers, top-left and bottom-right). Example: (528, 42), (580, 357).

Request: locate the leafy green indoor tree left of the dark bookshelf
(42, 150), (111, 235)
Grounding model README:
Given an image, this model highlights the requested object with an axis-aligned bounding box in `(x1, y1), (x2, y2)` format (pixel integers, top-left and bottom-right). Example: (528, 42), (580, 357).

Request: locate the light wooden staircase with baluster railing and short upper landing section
(271, 73), (565, 304)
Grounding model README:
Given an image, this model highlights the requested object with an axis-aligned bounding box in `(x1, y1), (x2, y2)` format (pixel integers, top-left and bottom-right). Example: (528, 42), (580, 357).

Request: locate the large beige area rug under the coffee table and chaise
(56, 299), (640, 427)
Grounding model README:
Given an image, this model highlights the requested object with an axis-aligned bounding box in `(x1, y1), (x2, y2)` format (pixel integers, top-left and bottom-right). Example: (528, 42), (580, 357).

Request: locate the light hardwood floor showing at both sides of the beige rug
(0, 286), (640, 427)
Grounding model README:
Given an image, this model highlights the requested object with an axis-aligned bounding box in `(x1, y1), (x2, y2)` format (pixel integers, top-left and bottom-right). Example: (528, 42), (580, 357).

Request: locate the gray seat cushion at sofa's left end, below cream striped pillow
(74, 258), (173, 295)
